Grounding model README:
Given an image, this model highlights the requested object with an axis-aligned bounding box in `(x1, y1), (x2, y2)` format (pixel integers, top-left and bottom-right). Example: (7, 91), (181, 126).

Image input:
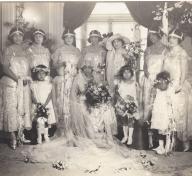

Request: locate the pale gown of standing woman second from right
(141, 47), (165, 120)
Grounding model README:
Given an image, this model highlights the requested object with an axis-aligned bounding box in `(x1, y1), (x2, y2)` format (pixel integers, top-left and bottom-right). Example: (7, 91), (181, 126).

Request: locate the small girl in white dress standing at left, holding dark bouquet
(31, 65), (56, 144)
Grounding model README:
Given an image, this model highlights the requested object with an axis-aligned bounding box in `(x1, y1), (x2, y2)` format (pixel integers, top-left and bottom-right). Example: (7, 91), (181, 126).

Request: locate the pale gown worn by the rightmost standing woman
(164, 45), (192, 141)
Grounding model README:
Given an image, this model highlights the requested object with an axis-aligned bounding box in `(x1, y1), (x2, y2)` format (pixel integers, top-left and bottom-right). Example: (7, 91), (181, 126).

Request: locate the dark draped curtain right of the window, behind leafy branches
(125, 1), (192, 36)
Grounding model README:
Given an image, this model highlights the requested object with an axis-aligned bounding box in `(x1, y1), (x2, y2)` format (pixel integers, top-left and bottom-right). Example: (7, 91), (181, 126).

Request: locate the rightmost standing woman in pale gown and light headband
(163, 29), (192, 151)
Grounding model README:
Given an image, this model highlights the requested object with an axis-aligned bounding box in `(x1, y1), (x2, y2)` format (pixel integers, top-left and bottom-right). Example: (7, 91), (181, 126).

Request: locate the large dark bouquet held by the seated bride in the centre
(85, 81), (111, 107)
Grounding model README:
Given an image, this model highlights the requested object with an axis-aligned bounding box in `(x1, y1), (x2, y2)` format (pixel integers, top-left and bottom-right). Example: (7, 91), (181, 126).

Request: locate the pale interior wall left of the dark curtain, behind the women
(0, 2), (64, 49)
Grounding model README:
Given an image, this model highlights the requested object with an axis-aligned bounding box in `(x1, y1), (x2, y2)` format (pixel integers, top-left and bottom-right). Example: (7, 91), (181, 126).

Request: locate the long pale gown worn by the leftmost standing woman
(0, 45), (31, 132)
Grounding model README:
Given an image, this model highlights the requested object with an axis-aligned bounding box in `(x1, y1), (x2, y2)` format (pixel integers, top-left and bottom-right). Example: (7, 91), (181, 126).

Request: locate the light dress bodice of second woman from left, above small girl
(27, 45), (50, 68)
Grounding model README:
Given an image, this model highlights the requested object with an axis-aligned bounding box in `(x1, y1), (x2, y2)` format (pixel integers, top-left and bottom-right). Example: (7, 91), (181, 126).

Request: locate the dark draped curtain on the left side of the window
(63, 2), (96, 30)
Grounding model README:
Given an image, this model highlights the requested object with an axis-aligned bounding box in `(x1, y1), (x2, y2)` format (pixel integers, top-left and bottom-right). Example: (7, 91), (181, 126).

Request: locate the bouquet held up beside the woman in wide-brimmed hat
(126, 42), (144, 70)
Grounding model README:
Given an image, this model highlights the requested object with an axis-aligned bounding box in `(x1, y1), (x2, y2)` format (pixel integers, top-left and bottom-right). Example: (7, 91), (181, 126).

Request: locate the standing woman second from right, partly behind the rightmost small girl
(140, 28), (165, 149)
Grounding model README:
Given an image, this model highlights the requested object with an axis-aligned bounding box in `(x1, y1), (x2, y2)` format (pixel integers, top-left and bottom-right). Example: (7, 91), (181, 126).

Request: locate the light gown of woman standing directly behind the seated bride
(80, 45), (106, 83)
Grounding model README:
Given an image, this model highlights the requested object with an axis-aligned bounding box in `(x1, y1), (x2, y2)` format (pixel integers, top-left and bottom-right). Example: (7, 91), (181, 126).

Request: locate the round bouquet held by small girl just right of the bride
(115, 96), (138, 117)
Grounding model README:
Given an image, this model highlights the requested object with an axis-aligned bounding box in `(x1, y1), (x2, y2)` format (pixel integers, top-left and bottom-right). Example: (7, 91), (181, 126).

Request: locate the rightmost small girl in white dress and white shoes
(151, 71), (175, 154)
